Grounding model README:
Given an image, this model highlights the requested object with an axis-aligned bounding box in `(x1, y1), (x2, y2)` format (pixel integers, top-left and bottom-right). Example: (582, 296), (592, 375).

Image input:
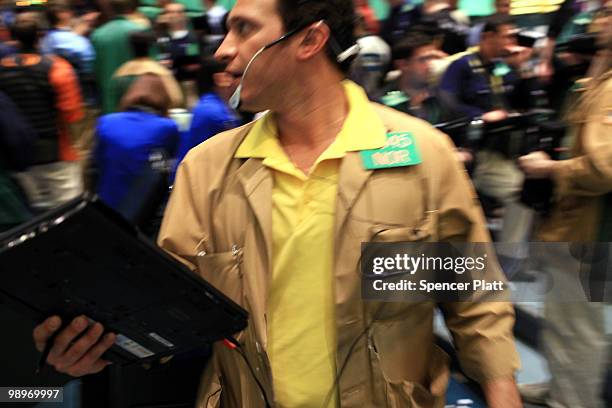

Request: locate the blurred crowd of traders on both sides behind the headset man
(0, 0), (599, 230)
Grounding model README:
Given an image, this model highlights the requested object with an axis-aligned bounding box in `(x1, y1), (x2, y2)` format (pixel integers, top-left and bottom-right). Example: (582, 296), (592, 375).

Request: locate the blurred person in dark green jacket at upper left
(91, 0), (147, 113)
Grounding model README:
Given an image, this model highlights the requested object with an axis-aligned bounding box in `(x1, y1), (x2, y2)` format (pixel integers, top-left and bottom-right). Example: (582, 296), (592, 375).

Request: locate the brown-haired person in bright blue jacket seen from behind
(94, 74), (179, 209)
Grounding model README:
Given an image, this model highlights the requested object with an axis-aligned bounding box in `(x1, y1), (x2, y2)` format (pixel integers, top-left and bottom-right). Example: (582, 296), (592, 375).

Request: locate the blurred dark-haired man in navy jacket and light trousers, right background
(440, 14), (533, 274)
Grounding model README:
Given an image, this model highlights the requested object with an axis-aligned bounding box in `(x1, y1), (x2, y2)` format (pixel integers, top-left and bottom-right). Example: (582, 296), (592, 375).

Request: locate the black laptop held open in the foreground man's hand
(0, 195), (248, 364)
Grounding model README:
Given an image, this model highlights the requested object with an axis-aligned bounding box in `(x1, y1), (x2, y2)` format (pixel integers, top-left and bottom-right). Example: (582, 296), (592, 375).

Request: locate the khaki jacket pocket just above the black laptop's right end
(196, 246), (244, 306)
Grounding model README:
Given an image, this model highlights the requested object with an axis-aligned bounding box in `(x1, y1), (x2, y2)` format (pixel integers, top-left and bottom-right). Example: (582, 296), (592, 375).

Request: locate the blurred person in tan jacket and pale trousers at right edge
(519, 1), (612, 408)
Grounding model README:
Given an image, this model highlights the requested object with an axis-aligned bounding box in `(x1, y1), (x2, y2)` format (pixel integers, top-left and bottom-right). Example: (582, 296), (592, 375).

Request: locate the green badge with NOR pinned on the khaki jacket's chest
(360, 132), (421, 170)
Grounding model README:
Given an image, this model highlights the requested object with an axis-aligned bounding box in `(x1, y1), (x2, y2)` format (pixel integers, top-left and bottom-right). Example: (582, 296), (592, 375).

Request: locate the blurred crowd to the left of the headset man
(0, 0), (242, 225)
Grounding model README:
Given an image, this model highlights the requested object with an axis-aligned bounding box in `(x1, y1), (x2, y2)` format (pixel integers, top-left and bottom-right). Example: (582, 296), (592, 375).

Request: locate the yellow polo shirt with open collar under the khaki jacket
(235, 81), (386, 408)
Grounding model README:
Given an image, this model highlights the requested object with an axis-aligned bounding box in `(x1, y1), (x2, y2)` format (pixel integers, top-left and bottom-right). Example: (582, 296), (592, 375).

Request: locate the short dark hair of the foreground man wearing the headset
(277, 0), (355, 73)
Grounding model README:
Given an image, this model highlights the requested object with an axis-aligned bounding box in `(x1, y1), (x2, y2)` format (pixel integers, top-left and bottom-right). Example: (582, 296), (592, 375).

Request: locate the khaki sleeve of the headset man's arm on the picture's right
(430, 131), (520, 383)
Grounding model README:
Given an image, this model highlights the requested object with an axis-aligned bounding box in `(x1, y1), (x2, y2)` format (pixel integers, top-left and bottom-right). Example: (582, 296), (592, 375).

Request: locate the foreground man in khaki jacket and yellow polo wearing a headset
(35, 0), (520, 408)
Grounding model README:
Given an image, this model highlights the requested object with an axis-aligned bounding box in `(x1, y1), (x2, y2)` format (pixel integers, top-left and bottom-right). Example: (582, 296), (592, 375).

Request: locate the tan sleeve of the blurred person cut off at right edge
(553, 79), (612, 196)
